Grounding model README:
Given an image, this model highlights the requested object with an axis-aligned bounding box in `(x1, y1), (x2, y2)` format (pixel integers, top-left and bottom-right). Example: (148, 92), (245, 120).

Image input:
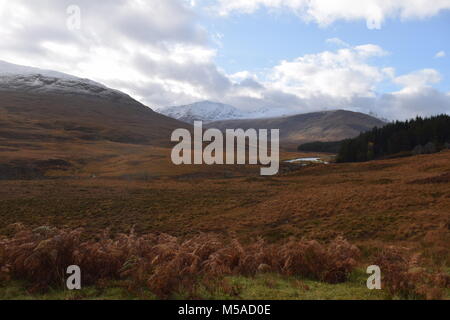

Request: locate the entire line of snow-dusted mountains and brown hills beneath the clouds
(0, 61), (385, 146)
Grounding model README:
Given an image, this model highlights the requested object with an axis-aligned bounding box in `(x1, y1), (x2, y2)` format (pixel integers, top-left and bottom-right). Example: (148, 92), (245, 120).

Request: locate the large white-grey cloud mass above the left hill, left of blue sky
(0, 0), (225, 106)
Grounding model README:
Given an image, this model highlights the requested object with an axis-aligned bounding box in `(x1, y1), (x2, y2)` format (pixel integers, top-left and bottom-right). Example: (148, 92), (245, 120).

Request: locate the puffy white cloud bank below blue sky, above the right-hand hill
(225, 53), (450, 119)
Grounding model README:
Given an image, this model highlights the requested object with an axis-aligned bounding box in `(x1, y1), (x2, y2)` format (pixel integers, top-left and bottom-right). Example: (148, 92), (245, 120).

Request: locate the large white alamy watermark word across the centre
(171, 121), (280, 176)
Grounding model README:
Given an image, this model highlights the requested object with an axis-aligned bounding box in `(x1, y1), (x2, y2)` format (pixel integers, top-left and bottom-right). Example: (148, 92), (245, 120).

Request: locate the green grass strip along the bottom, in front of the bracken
(0, 271), (386, 300)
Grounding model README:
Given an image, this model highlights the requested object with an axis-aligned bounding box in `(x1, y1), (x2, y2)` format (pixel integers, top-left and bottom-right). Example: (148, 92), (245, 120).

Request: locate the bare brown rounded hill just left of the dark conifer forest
(207, 110), (384, 143)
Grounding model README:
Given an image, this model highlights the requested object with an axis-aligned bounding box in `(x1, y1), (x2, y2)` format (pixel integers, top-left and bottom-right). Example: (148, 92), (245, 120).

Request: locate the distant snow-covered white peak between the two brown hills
(157, 101), (249, 123)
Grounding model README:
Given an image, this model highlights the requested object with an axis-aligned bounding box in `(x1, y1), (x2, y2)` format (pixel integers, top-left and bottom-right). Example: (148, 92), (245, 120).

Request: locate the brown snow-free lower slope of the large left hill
(0, 90), (187, 146)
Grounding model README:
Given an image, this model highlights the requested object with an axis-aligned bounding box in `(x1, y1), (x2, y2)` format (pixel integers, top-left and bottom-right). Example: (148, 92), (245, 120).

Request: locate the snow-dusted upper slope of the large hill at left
(0, 61), (130, 100)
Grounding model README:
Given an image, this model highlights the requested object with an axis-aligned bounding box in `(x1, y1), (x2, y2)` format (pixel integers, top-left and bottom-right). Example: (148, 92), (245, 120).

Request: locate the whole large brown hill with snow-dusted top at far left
(0, 61), (189, 146)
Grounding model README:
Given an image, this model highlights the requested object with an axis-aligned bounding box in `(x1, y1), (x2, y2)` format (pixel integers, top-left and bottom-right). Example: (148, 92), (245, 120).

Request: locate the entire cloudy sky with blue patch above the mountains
(0, 0), (450, 119)
